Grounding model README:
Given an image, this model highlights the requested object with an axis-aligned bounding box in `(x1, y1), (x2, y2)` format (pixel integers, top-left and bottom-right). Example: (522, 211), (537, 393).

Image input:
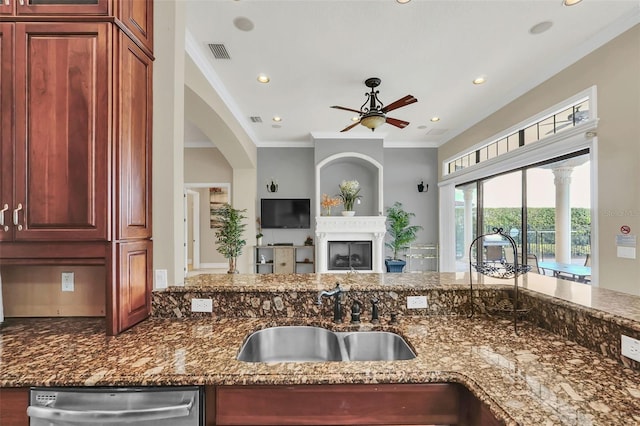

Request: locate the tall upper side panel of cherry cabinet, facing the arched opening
(115, 33), (153, 240)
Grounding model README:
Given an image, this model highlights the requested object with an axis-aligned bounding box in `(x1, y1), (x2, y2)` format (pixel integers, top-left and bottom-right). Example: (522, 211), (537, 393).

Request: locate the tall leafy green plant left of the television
(212, 203), (247, 274)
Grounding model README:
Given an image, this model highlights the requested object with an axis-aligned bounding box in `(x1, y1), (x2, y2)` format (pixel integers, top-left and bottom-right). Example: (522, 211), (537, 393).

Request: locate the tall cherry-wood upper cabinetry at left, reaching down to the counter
(0, 0), (153, 334)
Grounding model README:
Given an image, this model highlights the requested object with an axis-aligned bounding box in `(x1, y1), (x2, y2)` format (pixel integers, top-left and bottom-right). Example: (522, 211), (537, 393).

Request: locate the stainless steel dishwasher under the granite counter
(27, 386), (204, 426)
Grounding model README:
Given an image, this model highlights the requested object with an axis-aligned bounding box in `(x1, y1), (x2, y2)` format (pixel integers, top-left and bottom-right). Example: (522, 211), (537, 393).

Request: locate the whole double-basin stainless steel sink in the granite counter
(238, 326), (416, 362)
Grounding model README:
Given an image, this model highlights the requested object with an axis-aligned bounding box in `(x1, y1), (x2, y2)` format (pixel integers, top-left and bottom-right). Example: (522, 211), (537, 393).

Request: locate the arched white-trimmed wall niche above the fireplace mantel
(315, 152), (384, 217)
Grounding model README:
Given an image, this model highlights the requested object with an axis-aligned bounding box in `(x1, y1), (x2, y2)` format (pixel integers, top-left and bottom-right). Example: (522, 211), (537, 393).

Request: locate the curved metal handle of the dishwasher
(27, 399), (193, 424)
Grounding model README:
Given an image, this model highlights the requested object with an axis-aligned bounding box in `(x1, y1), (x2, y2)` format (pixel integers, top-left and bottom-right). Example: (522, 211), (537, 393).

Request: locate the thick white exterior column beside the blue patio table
(552, 167), (573, 263)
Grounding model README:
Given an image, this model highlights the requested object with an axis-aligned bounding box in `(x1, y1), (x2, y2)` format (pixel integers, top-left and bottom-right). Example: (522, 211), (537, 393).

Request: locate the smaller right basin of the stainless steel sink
(342, 331), (416, 361)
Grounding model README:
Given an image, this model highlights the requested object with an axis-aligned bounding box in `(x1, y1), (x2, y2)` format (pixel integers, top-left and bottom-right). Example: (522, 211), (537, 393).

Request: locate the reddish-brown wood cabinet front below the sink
(210, 383), (504, 426)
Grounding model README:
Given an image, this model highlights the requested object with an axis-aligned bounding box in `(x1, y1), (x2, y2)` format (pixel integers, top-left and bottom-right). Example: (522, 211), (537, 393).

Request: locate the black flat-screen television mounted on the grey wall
(260, 198), (311, 229)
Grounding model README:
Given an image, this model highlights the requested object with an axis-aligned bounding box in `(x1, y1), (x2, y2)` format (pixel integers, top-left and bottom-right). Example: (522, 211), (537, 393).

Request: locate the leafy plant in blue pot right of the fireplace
(385, 201), (422, 272)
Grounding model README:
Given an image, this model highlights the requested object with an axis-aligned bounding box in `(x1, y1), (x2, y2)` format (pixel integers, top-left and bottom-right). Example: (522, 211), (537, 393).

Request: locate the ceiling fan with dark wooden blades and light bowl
(331, 77), (418, 132)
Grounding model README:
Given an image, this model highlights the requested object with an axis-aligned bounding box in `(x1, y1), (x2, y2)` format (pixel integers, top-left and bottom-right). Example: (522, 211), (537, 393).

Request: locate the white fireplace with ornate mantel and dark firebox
(316, 216), (386, 273)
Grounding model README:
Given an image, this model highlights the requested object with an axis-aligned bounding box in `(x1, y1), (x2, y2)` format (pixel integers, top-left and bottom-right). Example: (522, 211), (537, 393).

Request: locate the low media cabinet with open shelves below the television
(256, 246), (315, 274)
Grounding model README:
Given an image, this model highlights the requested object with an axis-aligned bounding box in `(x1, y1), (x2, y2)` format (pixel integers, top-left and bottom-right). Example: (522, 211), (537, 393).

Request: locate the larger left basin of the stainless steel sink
(238, 326), (342, 362)
